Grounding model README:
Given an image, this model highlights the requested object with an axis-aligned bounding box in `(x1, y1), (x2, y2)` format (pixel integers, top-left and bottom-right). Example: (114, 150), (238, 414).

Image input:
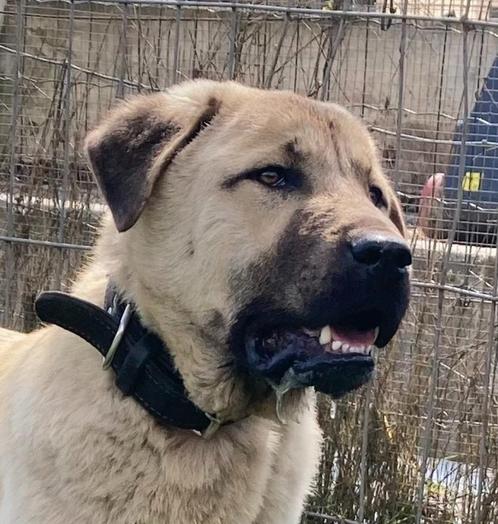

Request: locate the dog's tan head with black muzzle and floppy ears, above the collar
(87, 81), (411, 422)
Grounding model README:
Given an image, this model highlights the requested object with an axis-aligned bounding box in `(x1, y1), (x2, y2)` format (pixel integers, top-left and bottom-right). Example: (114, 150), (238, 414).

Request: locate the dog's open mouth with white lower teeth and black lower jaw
(241, 310), (385, 398)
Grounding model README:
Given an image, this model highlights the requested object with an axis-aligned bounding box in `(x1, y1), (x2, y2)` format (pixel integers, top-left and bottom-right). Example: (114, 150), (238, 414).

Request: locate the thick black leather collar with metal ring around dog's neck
(35, 286), (224, 437)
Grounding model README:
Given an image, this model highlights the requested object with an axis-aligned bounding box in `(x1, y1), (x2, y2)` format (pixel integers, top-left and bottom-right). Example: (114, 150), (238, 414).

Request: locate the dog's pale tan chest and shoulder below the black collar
(0, 320), (319, 524)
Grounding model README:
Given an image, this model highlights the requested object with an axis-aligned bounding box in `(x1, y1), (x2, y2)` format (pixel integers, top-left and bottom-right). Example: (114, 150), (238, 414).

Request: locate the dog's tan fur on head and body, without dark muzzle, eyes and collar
(0, 81), (404, 524)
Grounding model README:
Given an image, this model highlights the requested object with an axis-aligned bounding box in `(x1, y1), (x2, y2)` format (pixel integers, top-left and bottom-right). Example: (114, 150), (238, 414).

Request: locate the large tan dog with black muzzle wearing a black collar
(0, 80), (411, 524)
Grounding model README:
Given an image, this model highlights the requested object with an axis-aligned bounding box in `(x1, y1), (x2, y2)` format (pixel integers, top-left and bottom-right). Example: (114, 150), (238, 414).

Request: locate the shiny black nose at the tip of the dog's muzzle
(351, 235), (412, 269)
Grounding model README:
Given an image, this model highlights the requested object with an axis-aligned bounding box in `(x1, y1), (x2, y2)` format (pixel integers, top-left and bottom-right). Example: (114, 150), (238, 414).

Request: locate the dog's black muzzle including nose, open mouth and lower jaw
(231, 234), (411, 398)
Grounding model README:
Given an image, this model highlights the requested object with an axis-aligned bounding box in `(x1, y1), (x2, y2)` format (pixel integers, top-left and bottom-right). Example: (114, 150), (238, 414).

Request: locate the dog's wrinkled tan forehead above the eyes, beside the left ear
(206, 91), (376, 178)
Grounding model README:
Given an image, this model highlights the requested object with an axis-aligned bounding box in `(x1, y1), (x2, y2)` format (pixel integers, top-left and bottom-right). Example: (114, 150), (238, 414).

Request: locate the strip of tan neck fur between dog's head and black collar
(73, 217), (307, 426)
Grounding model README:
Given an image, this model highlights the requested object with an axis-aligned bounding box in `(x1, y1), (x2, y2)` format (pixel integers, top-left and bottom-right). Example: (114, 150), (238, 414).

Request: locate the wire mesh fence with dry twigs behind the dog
(0, 0), (498, 523)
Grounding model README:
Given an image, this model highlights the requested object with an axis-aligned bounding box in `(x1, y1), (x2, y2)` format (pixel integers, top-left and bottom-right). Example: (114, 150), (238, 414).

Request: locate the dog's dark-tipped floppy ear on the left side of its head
(85, 93), (218, 232)
